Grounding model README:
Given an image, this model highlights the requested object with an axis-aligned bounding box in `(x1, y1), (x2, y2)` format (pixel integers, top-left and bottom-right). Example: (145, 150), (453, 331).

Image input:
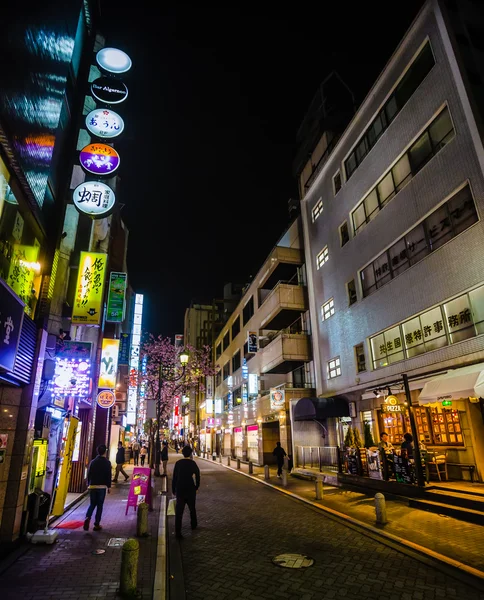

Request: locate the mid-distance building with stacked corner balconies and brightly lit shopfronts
(209, 216), (312, 464)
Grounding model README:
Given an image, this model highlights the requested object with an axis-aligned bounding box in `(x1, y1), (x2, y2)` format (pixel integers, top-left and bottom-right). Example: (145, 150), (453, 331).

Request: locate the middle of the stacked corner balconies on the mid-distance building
(259, 282), (308, 330)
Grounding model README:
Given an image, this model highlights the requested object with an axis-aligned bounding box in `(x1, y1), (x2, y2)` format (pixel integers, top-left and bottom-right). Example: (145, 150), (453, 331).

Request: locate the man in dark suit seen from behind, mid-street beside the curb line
(172, 446), (200, 538)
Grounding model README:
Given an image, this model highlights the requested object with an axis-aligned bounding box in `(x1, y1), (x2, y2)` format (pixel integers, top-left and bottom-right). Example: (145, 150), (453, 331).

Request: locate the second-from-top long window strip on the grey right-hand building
(351, 107), (455, 235)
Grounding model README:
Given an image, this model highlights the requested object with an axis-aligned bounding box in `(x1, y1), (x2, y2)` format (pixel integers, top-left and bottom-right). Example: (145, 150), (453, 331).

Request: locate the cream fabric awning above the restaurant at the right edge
(418, 363), (484, 404)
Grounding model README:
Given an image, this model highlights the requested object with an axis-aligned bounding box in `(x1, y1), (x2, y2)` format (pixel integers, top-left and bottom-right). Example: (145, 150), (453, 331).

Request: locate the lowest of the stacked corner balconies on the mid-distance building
(260, 330), (311, 374)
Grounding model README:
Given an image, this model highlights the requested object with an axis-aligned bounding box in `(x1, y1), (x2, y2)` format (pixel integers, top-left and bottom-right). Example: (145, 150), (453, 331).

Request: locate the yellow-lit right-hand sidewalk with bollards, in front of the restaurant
(210, 461), (484, 572)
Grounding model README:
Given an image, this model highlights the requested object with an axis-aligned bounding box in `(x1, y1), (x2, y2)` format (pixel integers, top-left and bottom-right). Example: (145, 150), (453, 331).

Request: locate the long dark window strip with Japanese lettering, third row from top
(360, 185), (478, 298)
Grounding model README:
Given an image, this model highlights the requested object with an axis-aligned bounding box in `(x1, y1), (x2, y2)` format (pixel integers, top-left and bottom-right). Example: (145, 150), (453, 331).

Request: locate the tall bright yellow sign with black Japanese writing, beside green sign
(72, 252), (108, 325)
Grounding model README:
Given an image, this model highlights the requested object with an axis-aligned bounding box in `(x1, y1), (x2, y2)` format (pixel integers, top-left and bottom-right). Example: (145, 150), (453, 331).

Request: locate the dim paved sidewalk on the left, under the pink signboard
(0, 465), (161, 600)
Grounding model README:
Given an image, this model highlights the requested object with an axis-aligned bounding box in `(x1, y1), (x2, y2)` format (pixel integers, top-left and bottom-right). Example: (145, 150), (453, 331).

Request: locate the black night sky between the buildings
(101, 0), (423, 336)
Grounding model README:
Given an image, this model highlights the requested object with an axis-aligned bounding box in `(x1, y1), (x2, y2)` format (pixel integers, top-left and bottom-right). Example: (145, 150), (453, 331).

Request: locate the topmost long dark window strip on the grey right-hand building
(344, 42), (435, 179)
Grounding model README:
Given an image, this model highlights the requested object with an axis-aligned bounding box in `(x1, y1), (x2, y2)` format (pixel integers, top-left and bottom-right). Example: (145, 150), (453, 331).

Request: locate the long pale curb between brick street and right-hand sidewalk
(197, 457), (484, 591)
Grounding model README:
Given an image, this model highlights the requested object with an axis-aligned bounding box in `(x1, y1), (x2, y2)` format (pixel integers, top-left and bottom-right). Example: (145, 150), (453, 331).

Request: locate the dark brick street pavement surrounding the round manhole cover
(173, 460), (484, 600)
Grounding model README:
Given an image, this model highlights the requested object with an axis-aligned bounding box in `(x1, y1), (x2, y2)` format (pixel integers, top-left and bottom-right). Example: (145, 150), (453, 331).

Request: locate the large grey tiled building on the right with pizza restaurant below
(301, 0), (484, 478)
